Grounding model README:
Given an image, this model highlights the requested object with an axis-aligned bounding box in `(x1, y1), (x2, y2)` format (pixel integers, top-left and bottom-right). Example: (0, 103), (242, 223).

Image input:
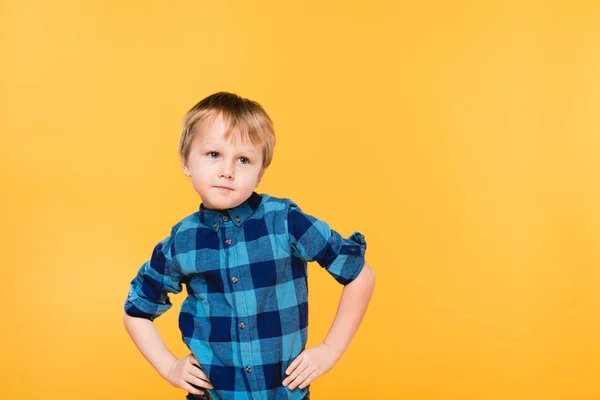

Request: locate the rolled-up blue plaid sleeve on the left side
(125, 235), (182, 321)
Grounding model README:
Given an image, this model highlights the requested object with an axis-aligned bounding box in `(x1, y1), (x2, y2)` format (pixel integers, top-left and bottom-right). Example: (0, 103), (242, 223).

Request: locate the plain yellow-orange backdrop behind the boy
(0, 0), (600, 400)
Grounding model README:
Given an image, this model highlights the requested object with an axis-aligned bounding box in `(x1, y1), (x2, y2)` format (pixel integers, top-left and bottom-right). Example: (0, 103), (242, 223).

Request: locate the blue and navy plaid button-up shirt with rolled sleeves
(125, 193), (366, 400)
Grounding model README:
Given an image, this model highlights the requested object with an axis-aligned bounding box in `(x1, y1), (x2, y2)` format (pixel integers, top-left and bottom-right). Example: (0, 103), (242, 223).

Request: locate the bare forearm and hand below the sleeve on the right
(283, 262), (375, 390)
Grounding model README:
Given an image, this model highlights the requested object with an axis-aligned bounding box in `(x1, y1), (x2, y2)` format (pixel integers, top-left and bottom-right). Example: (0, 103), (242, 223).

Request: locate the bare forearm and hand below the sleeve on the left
(123, 314), (213, 394)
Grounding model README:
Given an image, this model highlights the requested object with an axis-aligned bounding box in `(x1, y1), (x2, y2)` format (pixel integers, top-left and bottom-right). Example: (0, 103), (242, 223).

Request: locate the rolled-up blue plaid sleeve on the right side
(287, 202), (367, 285)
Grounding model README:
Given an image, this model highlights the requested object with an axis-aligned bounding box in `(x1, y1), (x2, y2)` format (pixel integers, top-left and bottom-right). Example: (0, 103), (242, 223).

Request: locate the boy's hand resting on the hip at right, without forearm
(283, 343), (341, 390)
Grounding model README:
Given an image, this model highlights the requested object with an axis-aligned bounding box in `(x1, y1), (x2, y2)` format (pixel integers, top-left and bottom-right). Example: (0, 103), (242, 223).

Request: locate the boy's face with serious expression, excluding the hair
(182, 115), (263, 210)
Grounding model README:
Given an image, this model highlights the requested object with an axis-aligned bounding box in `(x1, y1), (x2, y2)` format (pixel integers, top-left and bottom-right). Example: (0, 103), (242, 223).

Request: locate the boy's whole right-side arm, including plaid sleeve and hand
(283, 202), (375, 390)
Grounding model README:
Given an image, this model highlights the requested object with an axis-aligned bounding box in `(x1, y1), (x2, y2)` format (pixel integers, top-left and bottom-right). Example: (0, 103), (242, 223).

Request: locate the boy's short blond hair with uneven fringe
(179, 92), (275, 168)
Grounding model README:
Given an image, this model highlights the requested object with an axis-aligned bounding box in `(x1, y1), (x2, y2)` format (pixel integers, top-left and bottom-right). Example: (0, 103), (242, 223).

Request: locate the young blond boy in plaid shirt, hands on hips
(124, 93), (375, 400)
